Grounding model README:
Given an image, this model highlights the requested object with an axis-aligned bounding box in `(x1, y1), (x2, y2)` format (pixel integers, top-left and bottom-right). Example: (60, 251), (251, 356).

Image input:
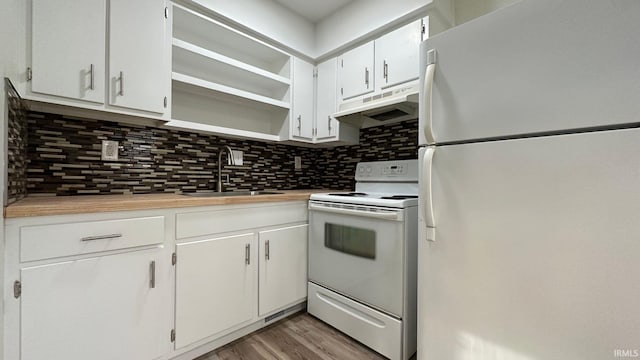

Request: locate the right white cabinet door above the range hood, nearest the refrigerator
(375, 20), (422, 89)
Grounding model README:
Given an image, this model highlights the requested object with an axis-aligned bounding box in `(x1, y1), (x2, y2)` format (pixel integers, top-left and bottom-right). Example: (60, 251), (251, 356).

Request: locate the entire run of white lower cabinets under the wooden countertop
(0, 201), (308, 360)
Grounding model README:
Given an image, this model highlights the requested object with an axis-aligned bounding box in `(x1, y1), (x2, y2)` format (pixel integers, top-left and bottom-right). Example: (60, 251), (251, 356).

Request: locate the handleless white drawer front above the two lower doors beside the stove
(176, 202), (308, 239)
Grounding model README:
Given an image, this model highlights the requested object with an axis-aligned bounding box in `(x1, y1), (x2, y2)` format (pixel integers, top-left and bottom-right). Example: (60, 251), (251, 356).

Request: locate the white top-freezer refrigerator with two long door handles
(417, 0), (640, 360)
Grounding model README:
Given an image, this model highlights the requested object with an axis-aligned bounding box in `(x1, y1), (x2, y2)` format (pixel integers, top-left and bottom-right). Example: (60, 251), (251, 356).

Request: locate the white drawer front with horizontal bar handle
(20, 216), (164, 262)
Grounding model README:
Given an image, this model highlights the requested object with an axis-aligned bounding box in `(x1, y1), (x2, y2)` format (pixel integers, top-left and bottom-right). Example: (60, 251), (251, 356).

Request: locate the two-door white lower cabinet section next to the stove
(174, 201), (308, 354)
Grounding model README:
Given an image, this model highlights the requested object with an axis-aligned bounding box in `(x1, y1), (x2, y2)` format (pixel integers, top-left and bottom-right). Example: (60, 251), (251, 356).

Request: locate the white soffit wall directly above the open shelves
(193, 0), (315, 57)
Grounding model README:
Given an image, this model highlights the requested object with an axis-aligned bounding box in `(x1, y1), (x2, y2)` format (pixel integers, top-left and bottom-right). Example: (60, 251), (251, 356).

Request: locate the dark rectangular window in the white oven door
(324, 223), (376, 259)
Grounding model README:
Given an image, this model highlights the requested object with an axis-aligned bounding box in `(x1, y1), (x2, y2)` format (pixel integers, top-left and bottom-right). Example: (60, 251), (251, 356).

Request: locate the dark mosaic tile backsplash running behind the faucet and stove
(17, 112), (417, 195)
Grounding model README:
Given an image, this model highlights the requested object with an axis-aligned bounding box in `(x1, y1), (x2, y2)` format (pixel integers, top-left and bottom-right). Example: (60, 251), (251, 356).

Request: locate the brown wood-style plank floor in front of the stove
(196, 313), (385, 360)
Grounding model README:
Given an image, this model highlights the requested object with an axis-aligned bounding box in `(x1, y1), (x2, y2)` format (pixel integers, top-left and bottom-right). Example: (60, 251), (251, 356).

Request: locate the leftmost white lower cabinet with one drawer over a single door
(0, 212), (172, 360)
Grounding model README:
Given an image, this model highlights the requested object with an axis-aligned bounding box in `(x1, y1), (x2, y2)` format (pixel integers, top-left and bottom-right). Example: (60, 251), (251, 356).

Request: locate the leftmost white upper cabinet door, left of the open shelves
(31, 0), (106, 103)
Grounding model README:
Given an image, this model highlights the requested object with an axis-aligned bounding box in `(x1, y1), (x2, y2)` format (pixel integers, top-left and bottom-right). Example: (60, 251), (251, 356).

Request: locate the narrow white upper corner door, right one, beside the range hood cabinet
(316, 58), (338, 140)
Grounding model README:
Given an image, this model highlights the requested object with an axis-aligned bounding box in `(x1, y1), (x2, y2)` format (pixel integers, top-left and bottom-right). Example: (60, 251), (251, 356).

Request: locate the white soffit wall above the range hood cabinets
(314, 0), (434, 58)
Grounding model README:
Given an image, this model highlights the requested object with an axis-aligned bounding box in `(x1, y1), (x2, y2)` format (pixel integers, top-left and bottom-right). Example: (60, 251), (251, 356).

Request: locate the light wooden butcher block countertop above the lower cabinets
(4, 189), (329, 218)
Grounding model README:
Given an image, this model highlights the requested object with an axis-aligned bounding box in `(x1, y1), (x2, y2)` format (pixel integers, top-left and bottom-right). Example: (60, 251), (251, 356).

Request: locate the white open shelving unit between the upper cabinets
(165, 4), (292, 141)
